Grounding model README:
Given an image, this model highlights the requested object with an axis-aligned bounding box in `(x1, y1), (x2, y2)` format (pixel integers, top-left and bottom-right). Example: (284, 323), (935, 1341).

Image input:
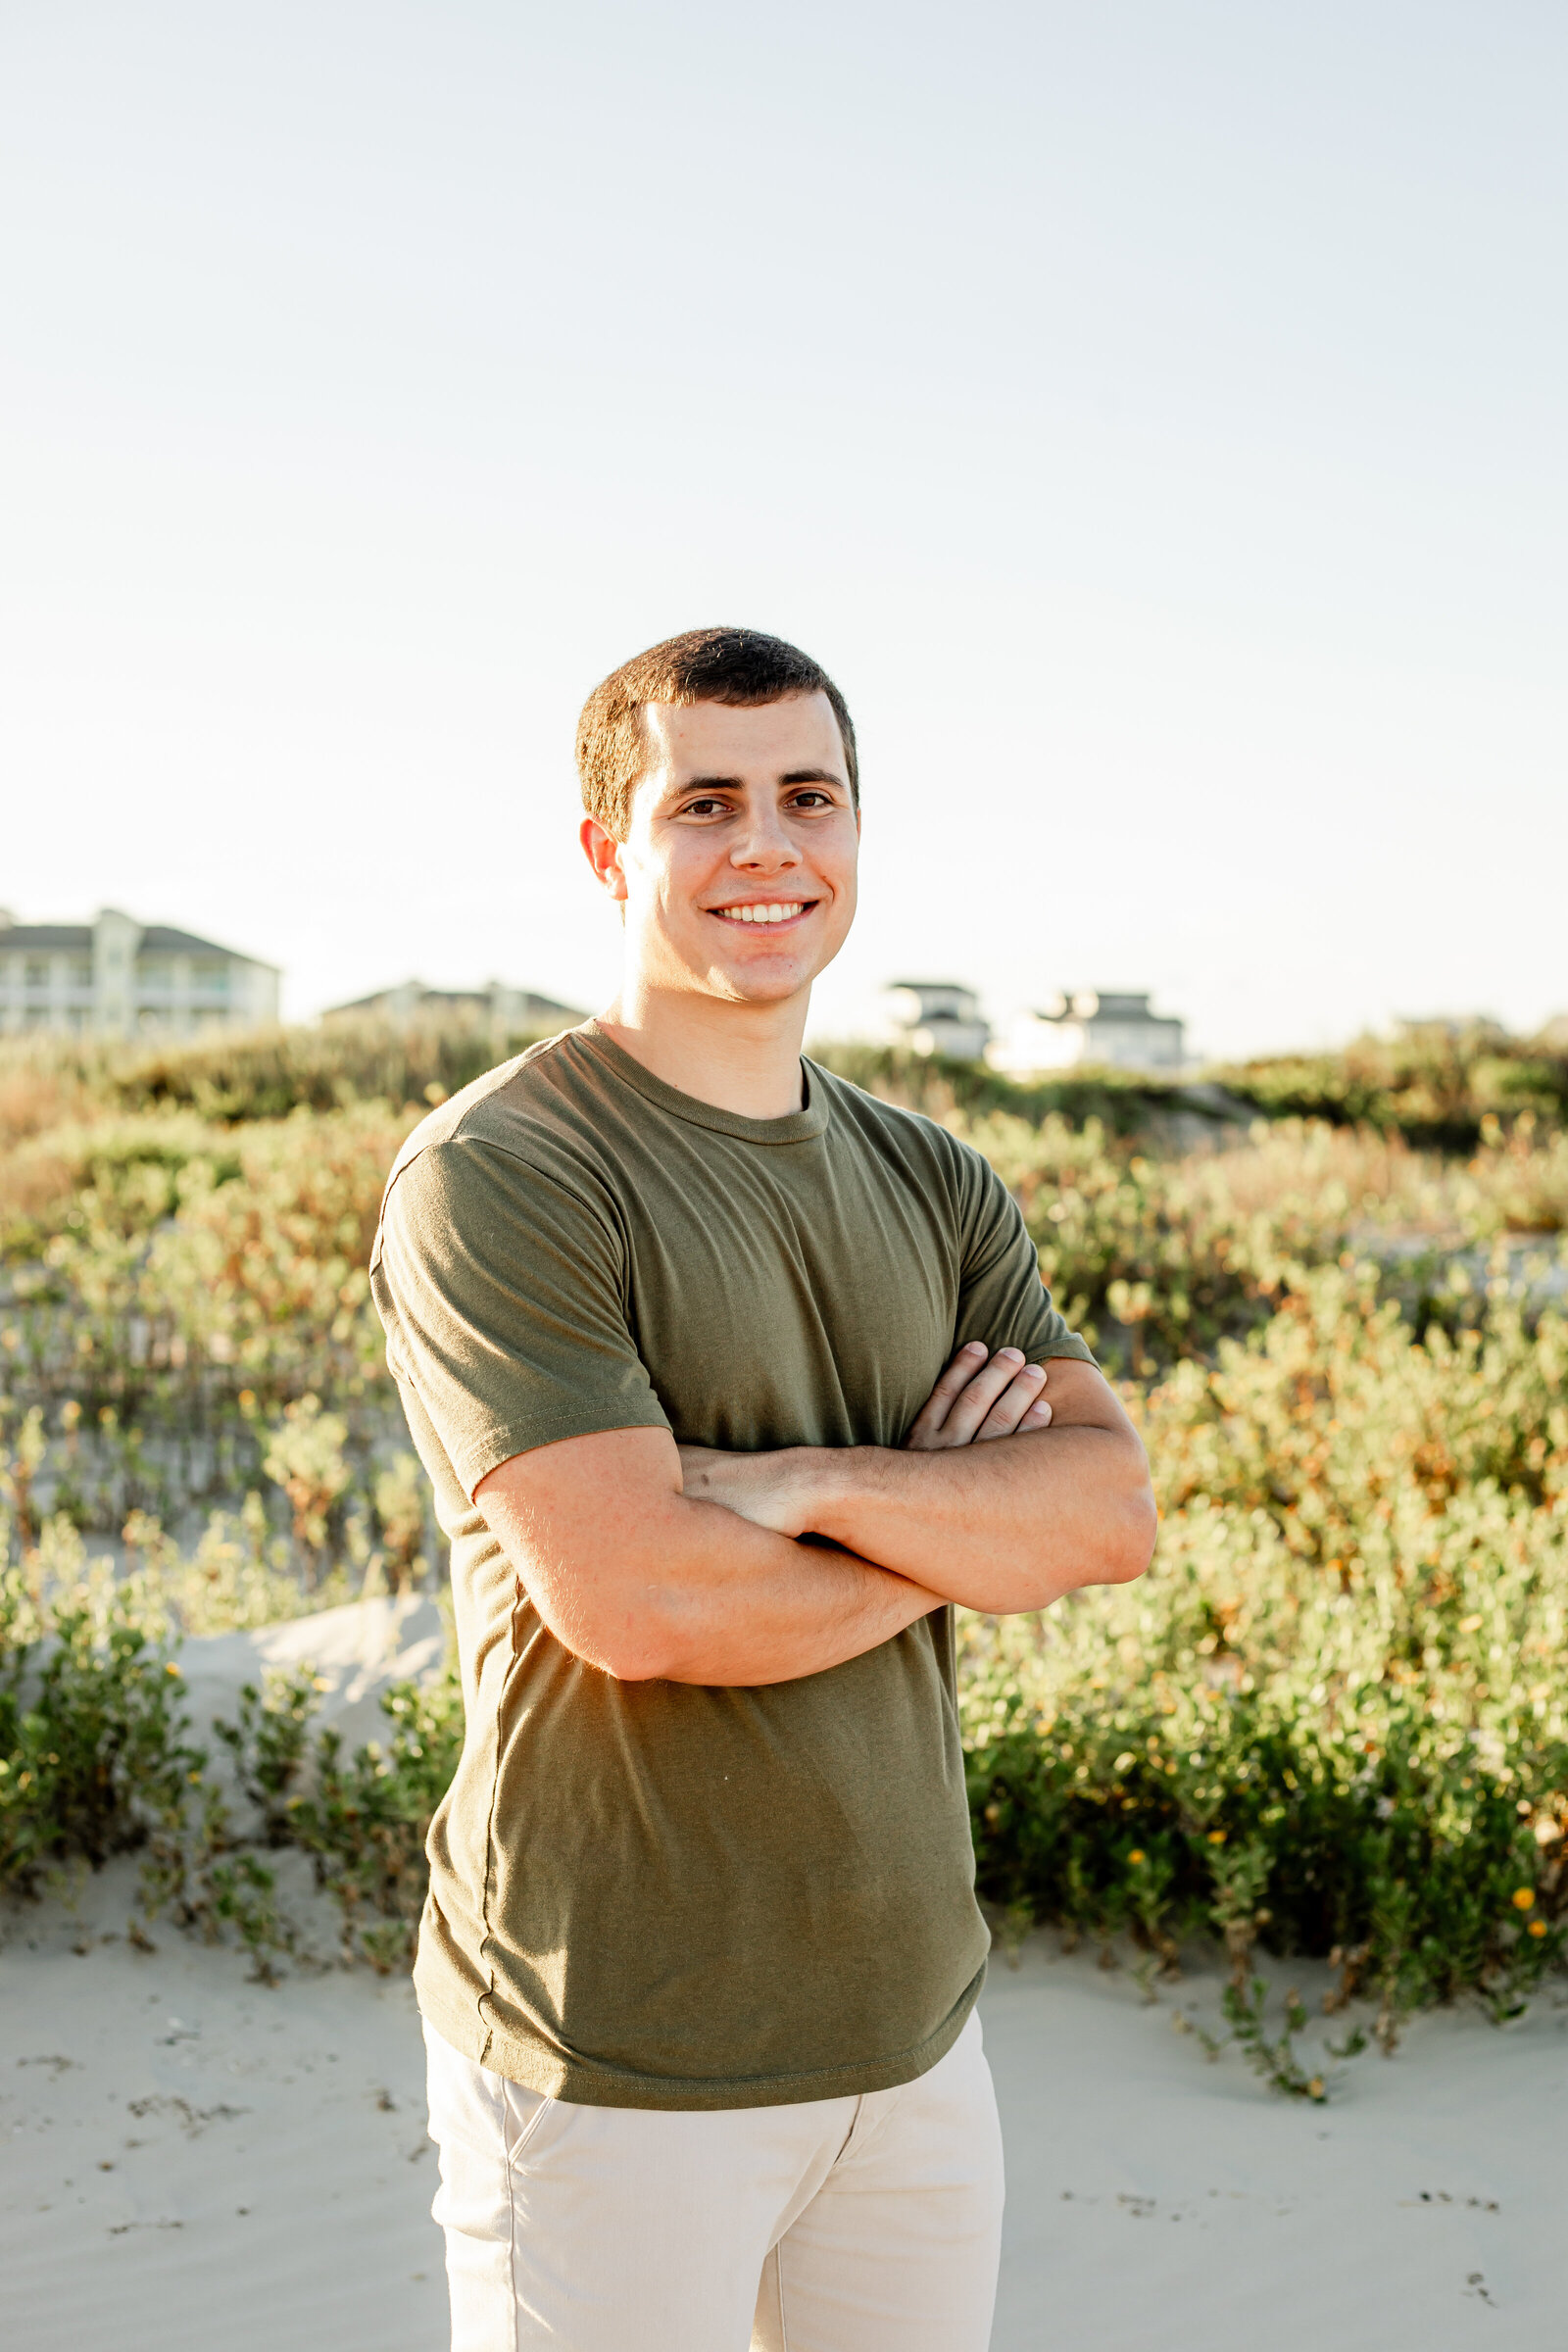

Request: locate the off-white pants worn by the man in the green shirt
(425, 2016), (1002, 2352)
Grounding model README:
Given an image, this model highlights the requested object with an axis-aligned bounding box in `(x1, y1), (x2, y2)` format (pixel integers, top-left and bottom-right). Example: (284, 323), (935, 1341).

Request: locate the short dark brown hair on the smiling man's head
(576, 628), (860, 842)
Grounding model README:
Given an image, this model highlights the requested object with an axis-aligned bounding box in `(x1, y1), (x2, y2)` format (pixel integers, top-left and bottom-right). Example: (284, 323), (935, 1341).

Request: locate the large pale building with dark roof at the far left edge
(0, 906), (277, 1037)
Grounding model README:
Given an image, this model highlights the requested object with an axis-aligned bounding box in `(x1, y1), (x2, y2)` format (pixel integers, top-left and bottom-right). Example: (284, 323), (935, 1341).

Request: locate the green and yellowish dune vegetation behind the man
(0, 1028), (1568, 2095)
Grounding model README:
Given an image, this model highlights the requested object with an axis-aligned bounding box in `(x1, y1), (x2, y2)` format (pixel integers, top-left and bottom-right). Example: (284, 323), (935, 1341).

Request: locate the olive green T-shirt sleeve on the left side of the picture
(371, 1136), (670, 1498)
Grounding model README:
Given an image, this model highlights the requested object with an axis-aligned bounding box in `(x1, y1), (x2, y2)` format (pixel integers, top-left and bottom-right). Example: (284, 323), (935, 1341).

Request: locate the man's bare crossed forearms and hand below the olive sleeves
(475, 1343), (1154, 1684)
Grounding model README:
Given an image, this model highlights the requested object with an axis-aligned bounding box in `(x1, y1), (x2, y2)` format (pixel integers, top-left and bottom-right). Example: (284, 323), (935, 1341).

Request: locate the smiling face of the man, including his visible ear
(583, 694), (860, 1004)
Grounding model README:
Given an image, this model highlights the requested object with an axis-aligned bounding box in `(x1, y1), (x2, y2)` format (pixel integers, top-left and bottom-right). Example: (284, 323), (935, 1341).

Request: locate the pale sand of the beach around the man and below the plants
(0, 1601), (1568, 2352)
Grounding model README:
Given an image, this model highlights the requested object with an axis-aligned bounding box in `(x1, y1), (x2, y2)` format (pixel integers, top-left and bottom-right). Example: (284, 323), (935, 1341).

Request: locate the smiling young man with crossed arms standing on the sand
(371, 630), (1154, 2352)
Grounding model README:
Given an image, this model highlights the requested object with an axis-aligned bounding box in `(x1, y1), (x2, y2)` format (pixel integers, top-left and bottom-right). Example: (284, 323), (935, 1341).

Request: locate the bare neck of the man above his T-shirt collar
(600, 981), (811, 1119)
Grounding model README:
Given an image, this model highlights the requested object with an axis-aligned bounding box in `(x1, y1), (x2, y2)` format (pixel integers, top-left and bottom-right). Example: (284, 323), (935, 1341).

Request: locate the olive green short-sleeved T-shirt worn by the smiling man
(371, 1021), (1089, 2107)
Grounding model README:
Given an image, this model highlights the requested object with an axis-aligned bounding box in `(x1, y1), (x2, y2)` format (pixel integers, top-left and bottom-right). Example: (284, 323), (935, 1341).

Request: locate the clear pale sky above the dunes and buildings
(0, 0), (1568, 1052)
